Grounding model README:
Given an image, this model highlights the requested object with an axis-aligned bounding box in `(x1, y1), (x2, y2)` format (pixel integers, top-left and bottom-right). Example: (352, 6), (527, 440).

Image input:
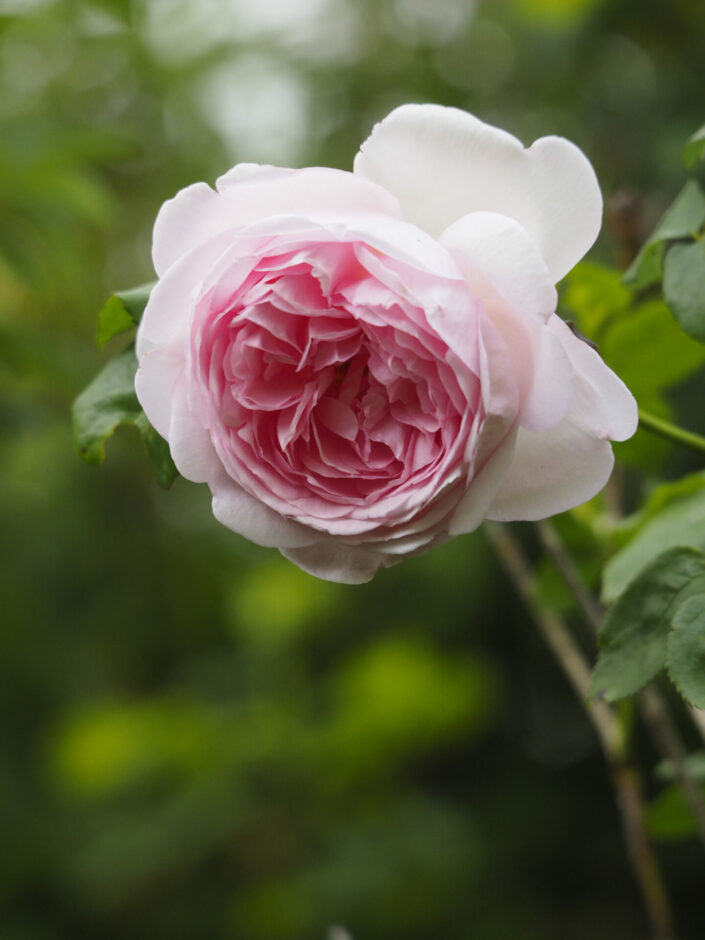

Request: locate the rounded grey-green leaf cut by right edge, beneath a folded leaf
(663, 241), (705, 343)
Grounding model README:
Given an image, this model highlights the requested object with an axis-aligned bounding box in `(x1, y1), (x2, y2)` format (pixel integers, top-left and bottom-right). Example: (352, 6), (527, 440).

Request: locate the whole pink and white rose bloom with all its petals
(136, 105), (637, 583)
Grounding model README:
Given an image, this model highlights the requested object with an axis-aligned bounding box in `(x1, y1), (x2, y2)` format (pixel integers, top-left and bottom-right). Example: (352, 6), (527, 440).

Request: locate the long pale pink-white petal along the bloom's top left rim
(152, 164), (401, 277)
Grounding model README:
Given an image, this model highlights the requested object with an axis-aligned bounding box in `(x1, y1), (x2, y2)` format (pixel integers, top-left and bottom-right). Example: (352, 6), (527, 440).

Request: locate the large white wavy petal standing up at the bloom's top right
(355, 104), (602, 281)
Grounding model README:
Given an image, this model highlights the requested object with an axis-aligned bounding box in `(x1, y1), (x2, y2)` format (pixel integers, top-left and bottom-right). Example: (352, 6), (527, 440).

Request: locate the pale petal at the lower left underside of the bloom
(208, 471), (321, 549)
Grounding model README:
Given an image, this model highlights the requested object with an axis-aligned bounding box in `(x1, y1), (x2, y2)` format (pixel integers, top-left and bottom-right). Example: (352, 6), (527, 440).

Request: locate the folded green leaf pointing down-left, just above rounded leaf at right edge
(622, 180), (705, 290)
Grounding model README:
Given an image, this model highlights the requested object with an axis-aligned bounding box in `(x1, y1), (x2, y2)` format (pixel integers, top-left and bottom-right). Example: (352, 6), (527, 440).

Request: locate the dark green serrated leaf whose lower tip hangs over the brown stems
(590, 548), (705, 702)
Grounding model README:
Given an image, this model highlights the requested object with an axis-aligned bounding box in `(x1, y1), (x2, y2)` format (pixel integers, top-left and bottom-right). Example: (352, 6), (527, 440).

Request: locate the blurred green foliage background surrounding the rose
(0, 0), (705, 940)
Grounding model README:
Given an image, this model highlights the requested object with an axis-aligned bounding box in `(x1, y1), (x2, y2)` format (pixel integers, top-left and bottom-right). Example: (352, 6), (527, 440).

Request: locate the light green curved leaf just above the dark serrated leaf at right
(602, 490), (705, 603)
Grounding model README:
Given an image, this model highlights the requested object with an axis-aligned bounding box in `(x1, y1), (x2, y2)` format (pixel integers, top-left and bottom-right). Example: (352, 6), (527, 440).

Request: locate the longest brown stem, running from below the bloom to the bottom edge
(484, 522), (675, 940)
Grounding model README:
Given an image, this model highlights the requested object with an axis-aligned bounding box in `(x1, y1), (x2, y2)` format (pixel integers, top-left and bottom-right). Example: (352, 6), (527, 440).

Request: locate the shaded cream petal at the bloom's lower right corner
(487, 415), (614, 522)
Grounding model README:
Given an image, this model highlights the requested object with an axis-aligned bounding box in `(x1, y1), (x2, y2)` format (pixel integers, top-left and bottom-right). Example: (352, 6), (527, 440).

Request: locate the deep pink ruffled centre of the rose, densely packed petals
(191, 242), (480, 529)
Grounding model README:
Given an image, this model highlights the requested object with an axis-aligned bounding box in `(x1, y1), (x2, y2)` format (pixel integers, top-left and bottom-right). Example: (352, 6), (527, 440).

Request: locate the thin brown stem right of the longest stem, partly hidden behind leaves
(535, 521), (705, 860)
